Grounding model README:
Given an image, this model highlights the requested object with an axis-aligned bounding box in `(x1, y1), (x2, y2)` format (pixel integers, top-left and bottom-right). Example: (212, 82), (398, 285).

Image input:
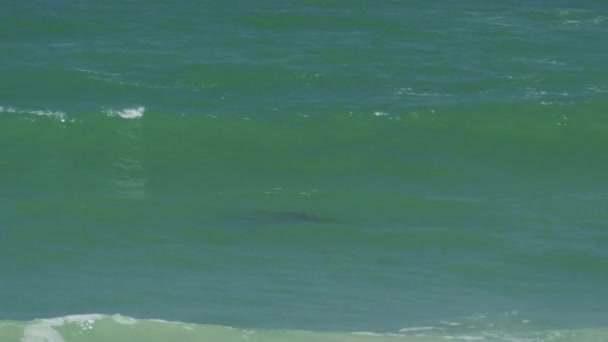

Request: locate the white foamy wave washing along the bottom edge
(0, 314), (608, 342)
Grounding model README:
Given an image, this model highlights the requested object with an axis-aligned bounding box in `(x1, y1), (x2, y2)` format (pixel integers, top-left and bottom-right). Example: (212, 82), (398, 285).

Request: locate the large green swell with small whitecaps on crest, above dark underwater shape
(0, 99), (608, 202)
